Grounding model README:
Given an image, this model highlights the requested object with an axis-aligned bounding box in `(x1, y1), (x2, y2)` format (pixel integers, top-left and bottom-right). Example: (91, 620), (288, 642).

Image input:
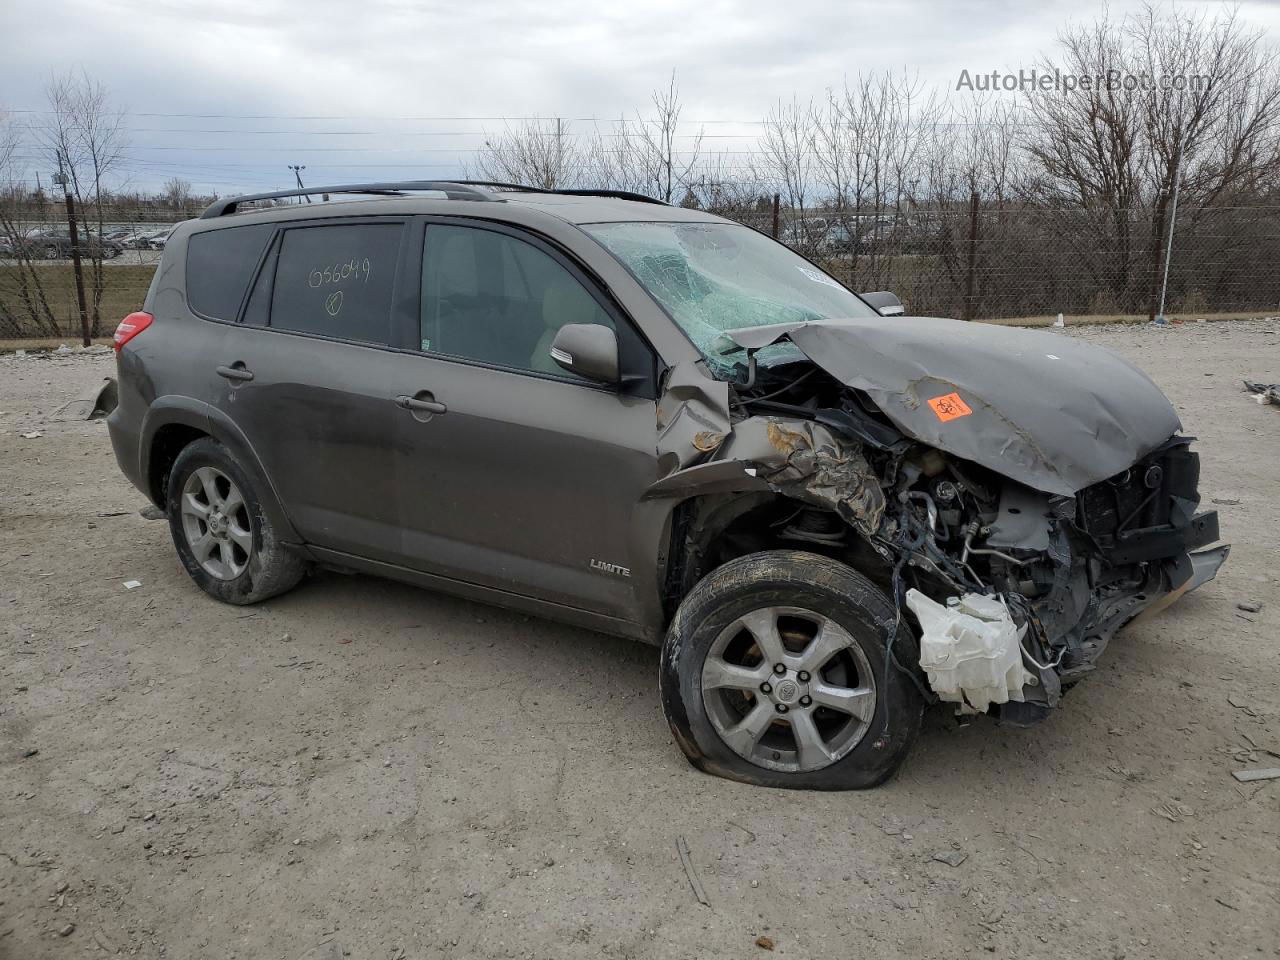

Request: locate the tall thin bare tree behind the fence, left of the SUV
(37, 72), (125, 337)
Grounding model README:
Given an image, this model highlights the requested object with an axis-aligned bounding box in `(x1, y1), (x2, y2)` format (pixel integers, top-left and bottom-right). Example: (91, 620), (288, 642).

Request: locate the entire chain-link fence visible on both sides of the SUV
(0, 200), (1280, 339)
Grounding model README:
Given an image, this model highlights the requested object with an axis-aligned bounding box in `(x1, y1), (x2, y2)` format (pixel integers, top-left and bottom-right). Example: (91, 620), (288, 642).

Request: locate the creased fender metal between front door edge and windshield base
(658, 362), (731, 474)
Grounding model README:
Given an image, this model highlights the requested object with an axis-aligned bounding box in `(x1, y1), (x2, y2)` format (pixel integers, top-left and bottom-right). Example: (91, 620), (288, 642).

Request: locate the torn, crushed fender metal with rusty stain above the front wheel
(724, 417), (884, 536)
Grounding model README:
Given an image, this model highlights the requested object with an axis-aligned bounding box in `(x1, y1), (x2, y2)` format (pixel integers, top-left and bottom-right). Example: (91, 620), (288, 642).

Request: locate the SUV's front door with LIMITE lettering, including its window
(390, 221), (658, 620)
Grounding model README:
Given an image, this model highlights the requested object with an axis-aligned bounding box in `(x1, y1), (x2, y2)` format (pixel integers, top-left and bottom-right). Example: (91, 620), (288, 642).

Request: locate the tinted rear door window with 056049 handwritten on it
(270, 223), (402, 343)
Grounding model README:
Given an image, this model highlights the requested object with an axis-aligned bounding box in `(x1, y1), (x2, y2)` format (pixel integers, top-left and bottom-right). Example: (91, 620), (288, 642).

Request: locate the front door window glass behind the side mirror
(420, 225), (613, 378)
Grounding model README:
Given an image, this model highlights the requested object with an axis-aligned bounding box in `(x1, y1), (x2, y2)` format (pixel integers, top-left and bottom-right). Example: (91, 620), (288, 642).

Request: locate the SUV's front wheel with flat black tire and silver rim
(659, 550), (924, 790)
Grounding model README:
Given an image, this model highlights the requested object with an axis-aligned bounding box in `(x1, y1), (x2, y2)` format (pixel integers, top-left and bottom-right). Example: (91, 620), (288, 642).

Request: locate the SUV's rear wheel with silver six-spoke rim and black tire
(165, 436), (307, 604)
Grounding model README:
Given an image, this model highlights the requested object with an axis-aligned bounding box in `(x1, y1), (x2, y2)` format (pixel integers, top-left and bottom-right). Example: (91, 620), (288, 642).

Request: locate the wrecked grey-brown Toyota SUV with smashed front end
(109, 182), (1228, 788)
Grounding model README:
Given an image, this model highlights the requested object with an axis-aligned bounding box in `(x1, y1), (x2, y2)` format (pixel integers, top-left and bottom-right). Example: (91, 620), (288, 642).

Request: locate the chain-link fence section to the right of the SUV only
(735, 201), (1280, 320)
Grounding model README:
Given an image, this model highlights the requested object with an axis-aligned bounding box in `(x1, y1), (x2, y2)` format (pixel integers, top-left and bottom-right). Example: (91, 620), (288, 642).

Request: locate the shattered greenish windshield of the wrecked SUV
(584, 223), (876, 369)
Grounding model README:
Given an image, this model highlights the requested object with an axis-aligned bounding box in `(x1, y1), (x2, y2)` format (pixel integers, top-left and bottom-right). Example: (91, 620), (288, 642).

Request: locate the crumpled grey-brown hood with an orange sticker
(726, 317), (1181, 495)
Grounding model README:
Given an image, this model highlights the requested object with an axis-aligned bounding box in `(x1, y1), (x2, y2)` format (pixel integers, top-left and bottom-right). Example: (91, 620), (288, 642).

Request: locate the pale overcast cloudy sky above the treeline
(0, 0), (1280, 193)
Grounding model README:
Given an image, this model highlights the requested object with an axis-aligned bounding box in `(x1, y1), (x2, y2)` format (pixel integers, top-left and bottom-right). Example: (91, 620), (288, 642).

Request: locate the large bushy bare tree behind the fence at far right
(1025, 5), (1280, 316)
